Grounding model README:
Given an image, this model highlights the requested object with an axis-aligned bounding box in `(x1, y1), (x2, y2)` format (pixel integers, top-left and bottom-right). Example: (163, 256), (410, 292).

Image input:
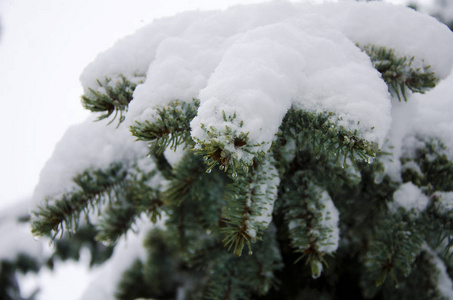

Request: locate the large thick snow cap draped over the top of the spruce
(76, 2), (453, 171)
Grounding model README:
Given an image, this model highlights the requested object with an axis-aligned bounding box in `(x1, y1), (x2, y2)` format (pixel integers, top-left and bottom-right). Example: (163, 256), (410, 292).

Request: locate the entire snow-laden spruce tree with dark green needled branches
(32, 3), (453, 299)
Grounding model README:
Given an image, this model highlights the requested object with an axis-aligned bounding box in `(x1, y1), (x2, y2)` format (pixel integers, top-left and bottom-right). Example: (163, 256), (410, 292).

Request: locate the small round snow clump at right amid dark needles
(389, 182), (429, 214)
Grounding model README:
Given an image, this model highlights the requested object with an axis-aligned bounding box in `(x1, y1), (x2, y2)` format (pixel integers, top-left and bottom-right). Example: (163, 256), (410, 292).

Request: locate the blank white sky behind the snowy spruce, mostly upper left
(0, 0), (430, 300)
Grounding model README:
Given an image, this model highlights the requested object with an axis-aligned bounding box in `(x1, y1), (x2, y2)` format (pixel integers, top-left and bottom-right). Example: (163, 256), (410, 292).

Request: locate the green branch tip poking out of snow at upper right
(359, 45), (439, 101)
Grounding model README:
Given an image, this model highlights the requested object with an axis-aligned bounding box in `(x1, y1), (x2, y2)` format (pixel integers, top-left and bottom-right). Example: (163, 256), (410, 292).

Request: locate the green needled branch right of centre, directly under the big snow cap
(273, 107), (379, 167)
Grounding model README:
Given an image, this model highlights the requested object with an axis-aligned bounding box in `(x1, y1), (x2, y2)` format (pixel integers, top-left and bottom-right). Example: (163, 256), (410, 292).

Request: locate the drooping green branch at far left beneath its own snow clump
(32, 164), (127, 239)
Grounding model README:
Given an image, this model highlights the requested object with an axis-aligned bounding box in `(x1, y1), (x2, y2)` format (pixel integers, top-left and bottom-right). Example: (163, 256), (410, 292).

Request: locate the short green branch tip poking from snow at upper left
(82, 75), (144, 125)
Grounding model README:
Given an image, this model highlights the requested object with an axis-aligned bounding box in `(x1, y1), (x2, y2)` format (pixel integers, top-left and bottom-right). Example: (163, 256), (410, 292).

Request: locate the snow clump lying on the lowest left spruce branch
(32, 117), (150, 204)
